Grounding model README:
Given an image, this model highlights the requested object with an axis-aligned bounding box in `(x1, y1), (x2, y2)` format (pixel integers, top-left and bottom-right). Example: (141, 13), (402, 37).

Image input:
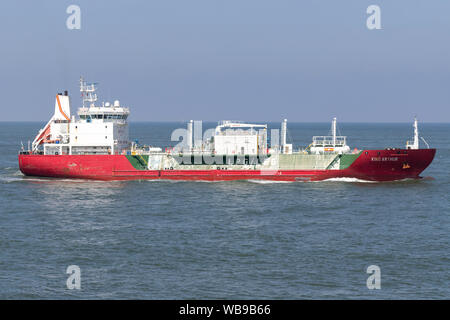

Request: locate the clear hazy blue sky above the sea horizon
(0, 0), (450, 122)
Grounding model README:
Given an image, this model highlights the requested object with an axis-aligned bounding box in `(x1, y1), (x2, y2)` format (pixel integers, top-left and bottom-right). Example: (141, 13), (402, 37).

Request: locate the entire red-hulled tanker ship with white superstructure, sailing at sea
(18, 78), (436, 181)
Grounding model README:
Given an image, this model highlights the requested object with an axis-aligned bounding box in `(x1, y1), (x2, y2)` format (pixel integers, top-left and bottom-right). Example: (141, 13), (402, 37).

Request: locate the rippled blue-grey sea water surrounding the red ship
(0, 122), (450, 299)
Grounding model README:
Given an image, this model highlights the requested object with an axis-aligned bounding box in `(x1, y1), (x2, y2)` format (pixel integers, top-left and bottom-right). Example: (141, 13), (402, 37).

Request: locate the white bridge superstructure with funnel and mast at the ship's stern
(33, 78), (130, 154)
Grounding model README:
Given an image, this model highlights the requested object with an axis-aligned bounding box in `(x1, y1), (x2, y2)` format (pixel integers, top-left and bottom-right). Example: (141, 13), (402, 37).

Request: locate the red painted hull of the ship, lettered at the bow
(19, 149), (436, 181)
